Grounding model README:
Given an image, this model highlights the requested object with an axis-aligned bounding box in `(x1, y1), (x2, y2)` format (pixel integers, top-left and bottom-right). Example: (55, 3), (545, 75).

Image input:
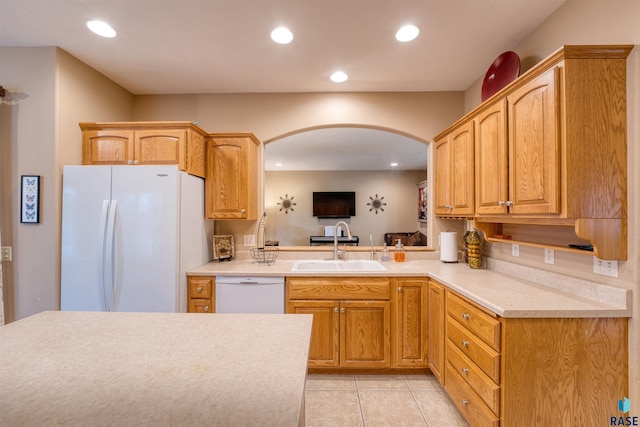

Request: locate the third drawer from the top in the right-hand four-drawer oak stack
(447, 341), (500, 414)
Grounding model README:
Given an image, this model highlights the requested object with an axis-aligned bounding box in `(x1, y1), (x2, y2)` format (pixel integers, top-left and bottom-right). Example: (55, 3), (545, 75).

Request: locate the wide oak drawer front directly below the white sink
(287, 277), (391, 300)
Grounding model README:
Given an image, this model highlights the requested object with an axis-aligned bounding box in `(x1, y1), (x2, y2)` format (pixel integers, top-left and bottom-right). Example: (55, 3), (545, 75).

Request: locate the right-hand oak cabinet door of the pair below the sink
(340, 301), (391, 368)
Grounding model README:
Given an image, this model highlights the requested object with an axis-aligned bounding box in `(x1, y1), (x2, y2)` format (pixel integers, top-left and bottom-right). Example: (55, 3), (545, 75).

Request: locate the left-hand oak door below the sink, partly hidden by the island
(287, 301), (340, 367)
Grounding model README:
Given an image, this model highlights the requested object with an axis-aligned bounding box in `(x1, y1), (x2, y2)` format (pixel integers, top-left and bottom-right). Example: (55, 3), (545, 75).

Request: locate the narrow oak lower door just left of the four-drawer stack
(428, 280), (446, 385)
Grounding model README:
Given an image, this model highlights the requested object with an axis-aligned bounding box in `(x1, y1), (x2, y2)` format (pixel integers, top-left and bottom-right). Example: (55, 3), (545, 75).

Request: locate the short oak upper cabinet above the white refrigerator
(80, 122), (206, 178)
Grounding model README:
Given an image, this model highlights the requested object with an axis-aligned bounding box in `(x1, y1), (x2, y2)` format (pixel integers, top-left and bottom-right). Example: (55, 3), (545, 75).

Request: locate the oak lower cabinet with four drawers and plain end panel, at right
(442, 288), (628, 427)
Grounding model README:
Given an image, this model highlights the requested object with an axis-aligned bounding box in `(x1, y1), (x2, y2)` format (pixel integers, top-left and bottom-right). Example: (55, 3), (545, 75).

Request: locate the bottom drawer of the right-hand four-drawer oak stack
(445, 365), (500, 427)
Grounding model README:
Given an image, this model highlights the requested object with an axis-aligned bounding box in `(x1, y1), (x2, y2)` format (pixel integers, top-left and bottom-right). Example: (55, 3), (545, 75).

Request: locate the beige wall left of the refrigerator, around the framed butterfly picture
(0, 47), (133, 321)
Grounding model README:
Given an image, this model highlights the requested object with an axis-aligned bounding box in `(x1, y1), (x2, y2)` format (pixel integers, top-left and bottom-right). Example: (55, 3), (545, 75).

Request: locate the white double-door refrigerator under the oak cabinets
(60, 166), (213, 312)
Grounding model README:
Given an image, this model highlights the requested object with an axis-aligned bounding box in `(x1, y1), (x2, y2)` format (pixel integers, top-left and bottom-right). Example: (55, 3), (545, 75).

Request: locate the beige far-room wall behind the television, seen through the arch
(265, 171), (427, 246)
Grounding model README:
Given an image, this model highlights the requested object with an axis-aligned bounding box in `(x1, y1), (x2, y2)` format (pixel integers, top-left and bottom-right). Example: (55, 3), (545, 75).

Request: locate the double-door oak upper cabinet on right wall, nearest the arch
(434, 121), (474, 216)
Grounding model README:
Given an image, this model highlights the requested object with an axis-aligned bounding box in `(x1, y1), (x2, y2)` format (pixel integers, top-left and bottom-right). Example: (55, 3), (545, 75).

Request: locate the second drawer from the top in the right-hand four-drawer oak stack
(447, 317), (500, 383)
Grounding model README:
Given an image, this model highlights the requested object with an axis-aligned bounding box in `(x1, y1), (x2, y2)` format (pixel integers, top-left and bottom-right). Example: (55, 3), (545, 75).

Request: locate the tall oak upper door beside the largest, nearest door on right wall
(474, 99), (509, 215)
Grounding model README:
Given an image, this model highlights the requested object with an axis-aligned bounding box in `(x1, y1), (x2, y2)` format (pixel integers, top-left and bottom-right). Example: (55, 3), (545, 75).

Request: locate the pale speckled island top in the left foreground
(0, 311), (312, 426)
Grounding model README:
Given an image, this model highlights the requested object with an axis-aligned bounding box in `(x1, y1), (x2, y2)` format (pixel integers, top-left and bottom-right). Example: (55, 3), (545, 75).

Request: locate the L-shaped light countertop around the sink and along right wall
(187, 259), (631, 318)
